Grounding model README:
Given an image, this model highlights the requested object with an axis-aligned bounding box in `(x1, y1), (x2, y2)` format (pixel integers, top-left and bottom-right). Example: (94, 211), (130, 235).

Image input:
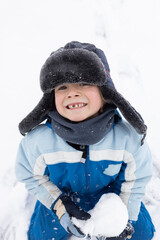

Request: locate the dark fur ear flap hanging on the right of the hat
(101, 85), (147, 135)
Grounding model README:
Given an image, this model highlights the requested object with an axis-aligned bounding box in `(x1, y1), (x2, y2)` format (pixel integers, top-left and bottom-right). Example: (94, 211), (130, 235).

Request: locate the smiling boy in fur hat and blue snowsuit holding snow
(16, 42), (154, 240)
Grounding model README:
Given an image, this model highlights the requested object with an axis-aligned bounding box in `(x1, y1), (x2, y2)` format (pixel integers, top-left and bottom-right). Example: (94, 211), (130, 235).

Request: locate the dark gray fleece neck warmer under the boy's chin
(48, 104), (120, 145)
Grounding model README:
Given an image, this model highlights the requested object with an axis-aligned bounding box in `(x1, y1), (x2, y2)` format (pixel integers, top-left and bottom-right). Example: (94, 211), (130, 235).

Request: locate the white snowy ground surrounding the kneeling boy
(0, 0), (160, 240)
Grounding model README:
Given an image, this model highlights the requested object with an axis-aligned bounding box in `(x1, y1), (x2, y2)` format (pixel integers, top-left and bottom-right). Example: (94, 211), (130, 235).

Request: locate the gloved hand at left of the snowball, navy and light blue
(53, 195), (91, 238)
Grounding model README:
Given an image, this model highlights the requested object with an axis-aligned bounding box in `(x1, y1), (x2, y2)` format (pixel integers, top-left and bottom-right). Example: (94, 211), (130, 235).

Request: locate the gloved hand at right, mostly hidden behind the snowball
(105, 222), (134, 240)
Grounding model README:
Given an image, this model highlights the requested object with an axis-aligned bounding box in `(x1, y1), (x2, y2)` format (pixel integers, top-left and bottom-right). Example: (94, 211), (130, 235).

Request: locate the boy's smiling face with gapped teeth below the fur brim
(55, 83), (103, 122)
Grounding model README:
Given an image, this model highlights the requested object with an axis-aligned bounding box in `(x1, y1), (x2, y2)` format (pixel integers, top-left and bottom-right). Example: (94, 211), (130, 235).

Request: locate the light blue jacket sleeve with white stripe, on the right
(114, 127), (152, 221)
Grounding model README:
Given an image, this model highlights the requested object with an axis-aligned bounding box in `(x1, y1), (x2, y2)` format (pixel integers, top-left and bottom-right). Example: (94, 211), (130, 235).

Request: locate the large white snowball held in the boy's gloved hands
(72, 193), (128, 237)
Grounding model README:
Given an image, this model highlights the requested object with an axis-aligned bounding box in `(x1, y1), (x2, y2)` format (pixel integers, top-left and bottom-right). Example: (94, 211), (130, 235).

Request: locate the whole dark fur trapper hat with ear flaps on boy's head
(19, 41), (147, 142)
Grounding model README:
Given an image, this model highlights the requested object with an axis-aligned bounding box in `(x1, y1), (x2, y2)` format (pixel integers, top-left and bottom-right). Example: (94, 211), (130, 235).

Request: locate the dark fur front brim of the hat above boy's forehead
(40, 48), (106, 92)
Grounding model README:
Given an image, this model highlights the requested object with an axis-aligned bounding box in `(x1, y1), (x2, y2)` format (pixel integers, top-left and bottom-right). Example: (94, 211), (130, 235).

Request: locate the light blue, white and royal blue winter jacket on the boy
(16, 121), (152, 221)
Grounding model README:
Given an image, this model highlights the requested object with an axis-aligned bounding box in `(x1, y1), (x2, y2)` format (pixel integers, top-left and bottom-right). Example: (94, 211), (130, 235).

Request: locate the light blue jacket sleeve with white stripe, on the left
(15, 135), (61, 209)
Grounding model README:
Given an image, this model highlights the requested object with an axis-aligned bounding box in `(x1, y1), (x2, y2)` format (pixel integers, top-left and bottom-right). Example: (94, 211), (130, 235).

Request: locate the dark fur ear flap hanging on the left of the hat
(18, 92), (54, 135)
